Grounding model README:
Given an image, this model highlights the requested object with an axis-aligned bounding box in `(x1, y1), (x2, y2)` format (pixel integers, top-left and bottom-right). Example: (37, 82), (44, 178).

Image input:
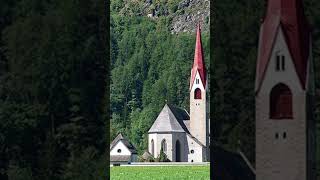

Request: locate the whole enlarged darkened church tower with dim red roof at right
(255, 0), (316, 180)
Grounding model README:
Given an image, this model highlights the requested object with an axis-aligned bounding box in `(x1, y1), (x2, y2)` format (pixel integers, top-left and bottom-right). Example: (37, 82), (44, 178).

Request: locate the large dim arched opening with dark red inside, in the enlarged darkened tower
(270, 83), (293, 119)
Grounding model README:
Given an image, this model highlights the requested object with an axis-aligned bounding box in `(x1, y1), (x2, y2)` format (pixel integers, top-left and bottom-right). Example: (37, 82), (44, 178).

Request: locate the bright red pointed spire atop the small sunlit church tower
(190, 23), (207, 89)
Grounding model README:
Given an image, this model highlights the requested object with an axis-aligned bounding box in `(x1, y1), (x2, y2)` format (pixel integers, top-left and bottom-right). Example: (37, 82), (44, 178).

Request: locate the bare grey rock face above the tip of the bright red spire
(171, 0), (210, 33)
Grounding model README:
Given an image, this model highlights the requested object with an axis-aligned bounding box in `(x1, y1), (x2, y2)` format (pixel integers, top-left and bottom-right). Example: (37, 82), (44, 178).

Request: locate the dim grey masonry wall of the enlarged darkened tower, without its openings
(256, 28), (306, 180)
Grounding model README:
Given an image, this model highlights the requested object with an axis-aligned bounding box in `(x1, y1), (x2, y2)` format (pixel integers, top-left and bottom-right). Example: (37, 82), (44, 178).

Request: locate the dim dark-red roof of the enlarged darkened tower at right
(257, 0), (310, 90)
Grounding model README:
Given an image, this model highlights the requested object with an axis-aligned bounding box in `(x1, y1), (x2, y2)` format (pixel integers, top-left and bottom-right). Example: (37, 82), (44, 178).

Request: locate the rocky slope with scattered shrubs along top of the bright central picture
(116, 0), (210, 33)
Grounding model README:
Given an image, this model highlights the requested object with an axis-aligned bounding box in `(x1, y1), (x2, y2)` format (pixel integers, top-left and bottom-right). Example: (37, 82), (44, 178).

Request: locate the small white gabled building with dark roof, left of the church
(110, 133), (138, 164)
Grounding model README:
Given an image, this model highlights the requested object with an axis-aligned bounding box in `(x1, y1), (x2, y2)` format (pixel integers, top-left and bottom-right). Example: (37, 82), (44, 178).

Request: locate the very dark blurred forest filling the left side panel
(0, 0), (108, 180)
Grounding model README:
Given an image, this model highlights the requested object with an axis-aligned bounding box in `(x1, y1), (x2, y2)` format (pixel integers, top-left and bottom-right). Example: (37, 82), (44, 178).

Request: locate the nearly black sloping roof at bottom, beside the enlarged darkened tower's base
(210, 145), (255, 180)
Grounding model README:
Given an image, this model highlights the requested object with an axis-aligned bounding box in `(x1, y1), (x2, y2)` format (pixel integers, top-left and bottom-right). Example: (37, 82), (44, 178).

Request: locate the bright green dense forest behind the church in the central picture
(110, 6), (210, 154)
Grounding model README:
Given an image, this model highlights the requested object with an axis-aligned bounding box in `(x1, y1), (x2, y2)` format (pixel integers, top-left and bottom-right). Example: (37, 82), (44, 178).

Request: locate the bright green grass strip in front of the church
(110, 165), (210, 180)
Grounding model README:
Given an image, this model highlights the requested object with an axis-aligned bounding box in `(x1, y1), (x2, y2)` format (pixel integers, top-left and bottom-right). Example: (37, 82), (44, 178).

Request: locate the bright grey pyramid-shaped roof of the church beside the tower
(148, 104), (189, 133)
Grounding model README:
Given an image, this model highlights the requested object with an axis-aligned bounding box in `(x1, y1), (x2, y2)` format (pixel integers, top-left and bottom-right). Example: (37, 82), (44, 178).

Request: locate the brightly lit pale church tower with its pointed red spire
(190, 24), (208, 147)
